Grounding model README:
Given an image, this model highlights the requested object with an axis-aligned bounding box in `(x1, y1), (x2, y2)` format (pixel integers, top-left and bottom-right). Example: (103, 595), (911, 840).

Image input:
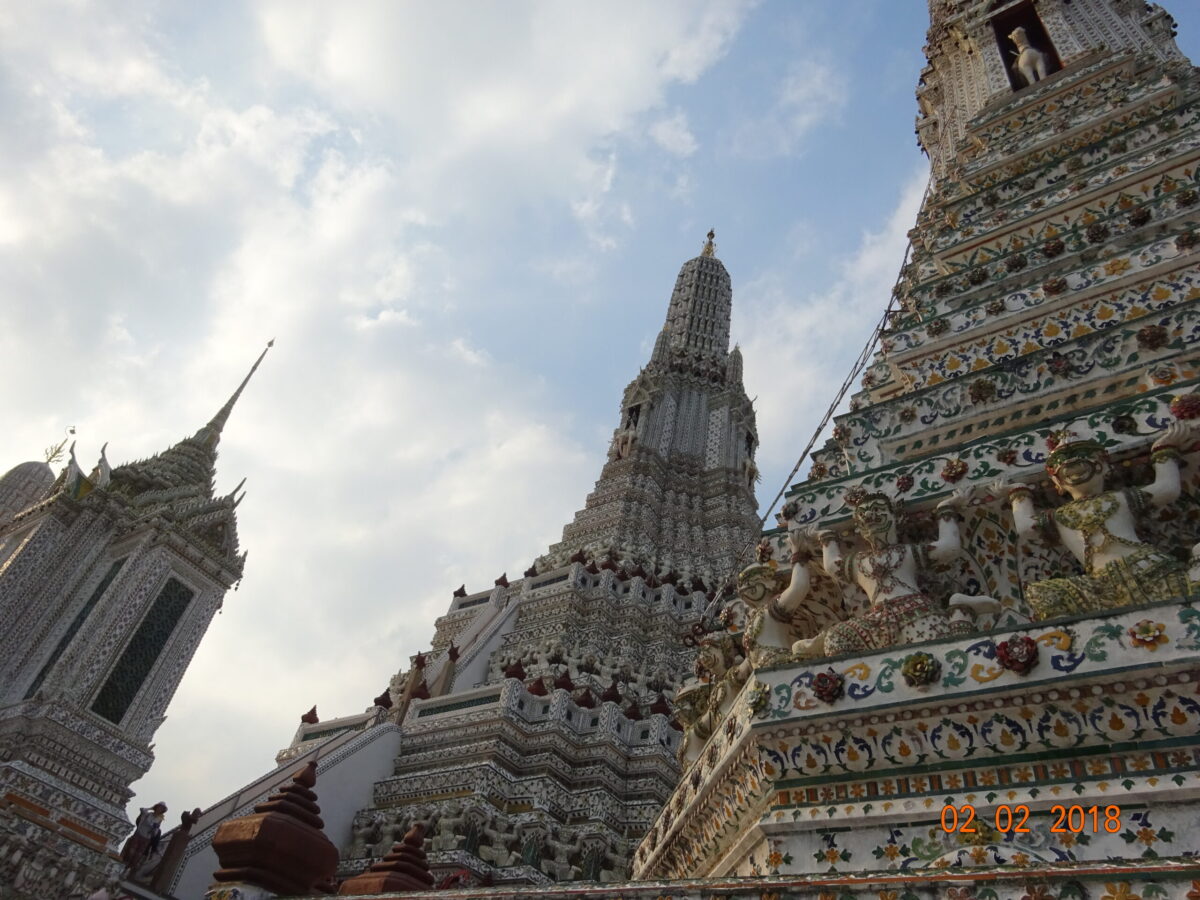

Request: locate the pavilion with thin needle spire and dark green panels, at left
(0, 350), (265, 896)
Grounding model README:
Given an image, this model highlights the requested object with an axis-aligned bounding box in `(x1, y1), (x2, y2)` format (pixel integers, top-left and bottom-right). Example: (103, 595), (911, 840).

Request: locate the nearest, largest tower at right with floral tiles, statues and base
(634, 0), (1200, 898)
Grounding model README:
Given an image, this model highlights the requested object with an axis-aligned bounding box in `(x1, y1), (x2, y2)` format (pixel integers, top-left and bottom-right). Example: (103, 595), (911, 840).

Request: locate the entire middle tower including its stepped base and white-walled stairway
(162, 234), (758, 896)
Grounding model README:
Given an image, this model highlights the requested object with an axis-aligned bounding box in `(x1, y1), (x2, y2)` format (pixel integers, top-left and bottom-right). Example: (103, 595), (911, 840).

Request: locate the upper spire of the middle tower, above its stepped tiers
(536, 232), (758, 588)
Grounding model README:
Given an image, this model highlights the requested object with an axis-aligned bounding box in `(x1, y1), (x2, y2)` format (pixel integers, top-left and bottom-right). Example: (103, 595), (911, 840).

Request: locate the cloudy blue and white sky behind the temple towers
(7, 0), (1200, 815)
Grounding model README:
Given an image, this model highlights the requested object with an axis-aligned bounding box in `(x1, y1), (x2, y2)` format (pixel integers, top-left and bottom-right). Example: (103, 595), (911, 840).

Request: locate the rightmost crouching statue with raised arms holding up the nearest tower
(994, 422), (1190, 619)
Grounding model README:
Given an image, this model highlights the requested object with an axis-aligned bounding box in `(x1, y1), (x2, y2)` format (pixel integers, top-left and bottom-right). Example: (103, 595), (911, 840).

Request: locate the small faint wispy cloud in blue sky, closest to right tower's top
(732, 59), (850, 160)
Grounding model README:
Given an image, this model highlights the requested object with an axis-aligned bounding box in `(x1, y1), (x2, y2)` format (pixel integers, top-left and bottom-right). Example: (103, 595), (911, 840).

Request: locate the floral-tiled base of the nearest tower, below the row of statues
(635, 601), (1200, 883)
